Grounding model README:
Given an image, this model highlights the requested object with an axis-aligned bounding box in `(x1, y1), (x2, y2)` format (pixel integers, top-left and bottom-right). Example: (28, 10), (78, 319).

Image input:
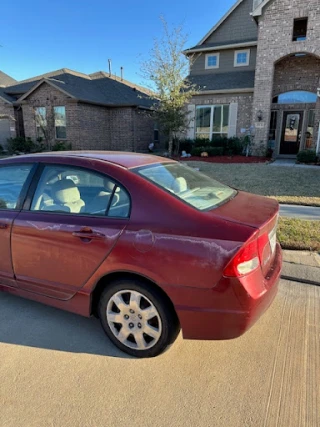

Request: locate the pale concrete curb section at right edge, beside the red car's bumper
(282, 250), (320, 286)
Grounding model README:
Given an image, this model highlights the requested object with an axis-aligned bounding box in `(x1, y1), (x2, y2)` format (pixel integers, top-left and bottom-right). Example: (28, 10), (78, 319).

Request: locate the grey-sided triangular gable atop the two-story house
(198, 0), (258, 45)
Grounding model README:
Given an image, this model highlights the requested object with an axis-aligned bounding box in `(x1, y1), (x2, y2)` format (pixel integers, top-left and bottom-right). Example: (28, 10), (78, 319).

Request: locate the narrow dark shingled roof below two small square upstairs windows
(188, 71), (255, 91)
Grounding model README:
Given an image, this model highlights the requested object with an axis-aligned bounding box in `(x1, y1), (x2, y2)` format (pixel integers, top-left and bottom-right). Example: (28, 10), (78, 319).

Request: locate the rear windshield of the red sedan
(134, 163), (237, 211)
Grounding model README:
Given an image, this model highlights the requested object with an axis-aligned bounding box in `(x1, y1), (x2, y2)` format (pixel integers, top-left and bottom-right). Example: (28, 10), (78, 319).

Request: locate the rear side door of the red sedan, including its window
(12, 164), (130, 300)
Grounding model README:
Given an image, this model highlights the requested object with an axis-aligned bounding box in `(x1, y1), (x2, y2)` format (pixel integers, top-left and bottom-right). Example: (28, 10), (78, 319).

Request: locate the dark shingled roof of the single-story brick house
(5, 69), (155, 108)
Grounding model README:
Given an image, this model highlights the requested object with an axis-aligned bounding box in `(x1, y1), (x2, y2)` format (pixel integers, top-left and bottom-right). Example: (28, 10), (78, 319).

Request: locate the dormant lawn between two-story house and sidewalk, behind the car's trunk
(187, 161), (320, 206)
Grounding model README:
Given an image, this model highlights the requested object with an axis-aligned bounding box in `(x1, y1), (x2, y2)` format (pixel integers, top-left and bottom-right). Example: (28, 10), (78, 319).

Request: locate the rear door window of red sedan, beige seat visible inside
(31, 165), (130, 218)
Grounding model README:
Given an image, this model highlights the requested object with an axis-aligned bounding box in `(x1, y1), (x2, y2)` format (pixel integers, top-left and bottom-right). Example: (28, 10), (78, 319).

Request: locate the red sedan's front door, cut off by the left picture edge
(0, 164), (32, 286)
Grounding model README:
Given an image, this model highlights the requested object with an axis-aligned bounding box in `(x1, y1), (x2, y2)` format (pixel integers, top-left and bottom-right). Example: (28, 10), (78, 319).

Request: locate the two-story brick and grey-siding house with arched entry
(185, 0), (320, 157)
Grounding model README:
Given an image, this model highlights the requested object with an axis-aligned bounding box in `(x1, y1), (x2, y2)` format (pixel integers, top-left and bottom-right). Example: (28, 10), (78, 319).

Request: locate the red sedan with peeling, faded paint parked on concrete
(0, 152), (282, 357)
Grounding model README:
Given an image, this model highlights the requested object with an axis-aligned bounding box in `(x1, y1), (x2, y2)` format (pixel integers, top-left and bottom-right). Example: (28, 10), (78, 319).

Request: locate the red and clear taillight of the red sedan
(223, 233), (269, 277)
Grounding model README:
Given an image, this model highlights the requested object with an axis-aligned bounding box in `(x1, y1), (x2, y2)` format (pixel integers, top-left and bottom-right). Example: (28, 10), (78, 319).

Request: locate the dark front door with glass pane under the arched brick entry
(280, 111), (303, 155)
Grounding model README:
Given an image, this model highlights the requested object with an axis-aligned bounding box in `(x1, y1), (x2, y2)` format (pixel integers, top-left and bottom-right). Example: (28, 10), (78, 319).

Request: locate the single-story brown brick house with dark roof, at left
(0, 69), (158, 151)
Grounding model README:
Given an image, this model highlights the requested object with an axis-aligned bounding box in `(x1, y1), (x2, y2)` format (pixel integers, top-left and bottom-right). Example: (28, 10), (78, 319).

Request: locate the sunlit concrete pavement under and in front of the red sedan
(0, 281), (320, 427)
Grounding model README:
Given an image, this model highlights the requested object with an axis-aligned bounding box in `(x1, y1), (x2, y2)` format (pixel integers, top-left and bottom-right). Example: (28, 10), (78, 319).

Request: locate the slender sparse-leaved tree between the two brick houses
(141, 17), (197, 156)
